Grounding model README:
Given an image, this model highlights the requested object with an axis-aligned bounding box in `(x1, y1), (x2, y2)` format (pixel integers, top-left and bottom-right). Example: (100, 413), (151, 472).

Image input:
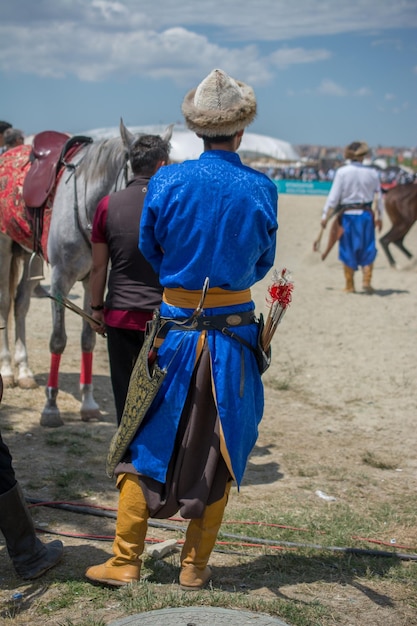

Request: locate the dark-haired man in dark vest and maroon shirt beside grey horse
(90, 135), (170, 424)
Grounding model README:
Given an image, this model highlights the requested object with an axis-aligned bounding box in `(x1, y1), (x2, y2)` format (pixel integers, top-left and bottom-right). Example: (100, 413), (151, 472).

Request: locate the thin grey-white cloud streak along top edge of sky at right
(90, 0), (417, 41)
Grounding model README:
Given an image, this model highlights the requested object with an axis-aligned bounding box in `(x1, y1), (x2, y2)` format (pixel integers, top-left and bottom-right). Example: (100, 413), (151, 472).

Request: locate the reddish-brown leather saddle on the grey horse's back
(22, 130), (92, 209)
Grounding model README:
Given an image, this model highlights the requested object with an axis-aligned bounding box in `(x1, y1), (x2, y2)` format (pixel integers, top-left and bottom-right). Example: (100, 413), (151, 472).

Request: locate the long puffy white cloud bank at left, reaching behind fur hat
(0, 25), (270, 84)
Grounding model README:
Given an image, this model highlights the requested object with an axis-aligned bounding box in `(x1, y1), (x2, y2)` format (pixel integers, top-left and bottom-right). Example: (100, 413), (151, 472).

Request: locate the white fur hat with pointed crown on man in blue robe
(182, 70), (256, 137)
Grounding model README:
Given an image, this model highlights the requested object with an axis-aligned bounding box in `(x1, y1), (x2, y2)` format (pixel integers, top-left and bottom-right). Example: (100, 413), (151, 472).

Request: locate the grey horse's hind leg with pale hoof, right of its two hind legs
(14, 252), (38, 389)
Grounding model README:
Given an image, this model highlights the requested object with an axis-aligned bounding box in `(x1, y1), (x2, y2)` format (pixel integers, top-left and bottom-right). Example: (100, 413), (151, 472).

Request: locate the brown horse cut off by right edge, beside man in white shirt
(379, 183), (417, 267)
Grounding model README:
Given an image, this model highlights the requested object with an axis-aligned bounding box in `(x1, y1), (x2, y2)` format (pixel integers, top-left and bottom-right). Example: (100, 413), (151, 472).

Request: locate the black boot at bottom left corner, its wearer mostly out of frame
(0, 483), (63, 580)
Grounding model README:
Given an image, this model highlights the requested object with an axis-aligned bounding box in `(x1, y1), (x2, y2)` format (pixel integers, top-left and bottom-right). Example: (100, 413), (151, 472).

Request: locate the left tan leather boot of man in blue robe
(85, 474), (149, 587)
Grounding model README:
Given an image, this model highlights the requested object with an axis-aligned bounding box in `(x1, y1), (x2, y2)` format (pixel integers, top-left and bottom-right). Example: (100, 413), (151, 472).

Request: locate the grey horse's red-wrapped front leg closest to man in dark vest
(80, 277), (101, 422)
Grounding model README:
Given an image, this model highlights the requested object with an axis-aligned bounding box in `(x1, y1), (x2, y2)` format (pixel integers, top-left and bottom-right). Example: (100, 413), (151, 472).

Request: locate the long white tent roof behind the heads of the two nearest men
(80, 125), (300, 162)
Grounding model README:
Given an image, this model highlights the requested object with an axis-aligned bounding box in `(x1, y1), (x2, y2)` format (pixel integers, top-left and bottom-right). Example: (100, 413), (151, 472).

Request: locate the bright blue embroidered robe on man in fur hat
(130, 150), (278, 485)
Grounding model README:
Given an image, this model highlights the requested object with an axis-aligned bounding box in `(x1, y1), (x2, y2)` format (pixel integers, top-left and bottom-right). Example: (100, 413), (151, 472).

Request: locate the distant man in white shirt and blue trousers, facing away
(321, 141), (383, 294)
